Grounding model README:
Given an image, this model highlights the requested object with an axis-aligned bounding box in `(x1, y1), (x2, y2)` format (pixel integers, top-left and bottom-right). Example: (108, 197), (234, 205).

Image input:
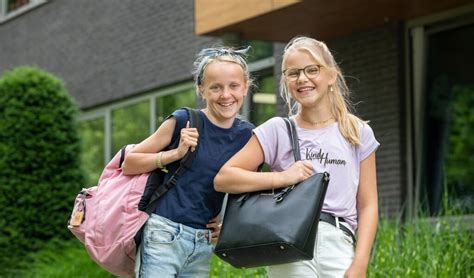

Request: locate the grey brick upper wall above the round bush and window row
(0, 0), (218, 109)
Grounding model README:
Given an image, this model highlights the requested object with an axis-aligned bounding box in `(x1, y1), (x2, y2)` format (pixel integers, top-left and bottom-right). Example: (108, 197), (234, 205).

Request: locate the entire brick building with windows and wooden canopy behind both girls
(0, 0), (474, 215)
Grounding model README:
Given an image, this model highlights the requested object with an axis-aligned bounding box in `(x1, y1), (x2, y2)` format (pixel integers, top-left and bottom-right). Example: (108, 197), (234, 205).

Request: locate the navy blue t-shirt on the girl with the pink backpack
(155, 109), (254, 229)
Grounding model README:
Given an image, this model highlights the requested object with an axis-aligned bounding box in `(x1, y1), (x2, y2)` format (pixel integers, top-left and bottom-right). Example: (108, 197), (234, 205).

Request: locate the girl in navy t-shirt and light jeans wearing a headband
(123, 45), (254, 277)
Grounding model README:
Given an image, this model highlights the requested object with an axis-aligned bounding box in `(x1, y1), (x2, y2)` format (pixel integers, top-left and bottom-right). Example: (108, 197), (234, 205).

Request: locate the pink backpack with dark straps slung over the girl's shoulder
(68, 109), (202, 277)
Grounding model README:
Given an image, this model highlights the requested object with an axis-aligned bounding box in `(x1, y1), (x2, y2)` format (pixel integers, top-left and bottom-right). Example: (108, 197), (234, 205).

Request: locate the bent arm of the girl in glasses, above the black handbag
(214, 135), (313, 193)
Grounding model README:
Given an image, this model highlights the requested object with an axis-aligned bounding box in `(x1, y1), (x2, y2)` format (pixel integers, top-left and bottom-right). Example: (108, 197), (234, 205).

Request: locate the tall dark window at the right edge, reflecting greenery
(421, 24), (474, 215)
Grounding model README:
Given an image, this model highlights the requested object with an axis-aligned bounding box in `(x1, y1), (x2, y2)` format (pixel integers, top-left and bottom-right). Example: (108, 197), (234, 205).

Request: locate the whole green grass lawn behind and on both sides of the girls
(4, 214), (474, 278)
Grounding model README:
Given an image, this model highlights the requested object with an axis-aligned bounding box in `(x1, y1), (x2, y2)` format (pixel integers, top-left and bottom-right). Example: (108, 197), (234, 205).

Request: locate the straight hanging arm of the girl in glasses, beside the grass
(344, 152), (378, 277)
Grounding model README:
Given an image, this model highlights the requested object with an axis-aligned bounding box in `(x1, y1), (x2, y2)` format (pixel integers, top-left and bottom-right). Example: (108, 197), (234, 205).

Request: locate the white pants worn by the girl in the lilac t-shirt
(267, 221), (354, 278)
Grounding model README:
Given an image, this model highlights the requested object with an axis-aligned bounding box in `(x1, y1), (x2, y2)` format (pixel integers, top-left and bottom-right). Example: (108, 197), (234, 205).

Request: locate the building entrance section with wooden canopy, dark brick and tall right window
(195, 0), (474, 216)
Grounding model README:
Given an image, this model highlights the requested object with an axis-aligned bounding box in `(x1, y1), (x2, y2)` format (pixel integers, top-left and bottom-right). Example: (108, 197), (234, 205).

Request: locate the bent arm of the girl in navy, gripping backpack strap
(122, 117), (199, 175)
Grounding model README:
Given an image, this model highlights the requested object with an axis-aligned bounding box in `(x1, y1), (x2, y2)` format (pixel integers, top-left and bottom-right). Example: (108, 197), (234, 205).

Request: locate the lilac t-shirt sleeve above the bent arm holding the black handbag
(253, 117), (285, 166)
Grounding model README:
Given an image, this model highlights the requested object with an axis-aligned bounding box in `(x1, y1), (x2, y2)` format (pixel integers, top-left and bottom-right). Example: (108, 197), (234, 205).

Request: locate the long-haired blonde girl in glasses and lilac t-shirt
(214, 37), (379, 277)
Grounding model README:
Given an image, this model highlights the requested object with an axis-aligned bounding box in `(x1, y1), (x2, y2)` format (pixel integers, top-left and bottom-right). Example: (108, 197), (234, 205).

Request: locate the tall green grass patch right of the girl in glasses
(368, 215), (474, 277)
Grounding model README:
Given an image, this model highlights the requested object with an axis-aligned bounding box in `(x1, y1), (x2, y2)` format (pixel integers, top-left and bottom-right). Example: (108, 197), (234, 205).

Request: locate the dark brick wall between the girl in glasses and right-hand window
(328, 23), (405, 215)
